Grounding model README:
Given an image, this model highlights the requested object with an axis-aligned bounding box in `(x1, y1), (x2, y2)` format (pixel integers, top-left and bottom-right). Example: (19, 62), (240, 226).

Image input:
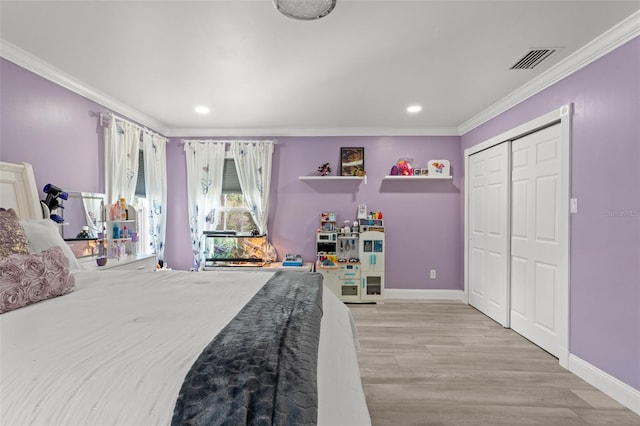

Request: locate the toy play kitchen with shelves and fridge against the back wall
(315, 205), (385, 302)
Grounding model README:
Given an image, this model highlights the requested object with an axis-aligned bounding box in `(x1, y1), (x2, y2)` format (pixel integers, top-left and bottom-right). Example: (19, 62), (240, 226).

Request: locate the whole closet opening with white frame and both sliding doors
(465, 106), (570, 366)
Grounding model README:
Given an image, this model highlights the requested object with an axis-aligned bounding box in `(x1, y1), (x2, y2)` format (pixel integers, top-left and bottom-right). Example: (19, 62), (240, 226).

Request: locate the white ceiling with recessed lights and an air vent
(0, 0), (640, 136)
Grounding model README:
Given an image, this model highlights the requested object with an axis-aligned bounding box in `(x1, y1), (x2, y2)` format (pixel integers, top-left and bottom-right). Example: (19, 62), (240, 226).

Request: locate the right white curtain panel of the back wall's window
(231, 141), (273, 235)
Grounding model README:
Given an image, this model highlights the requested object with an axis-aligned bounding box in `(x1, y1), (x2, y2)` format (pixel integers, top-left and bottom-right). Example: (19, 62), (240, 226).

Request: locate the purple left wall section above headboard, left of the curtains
(0, 58), (105, 197)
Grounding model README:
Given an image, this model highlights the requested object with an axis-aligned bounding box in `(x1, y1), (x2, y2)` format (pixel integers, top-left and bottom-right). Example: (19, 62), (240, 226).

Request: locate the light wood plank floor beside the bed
(348, 300), (640, 426)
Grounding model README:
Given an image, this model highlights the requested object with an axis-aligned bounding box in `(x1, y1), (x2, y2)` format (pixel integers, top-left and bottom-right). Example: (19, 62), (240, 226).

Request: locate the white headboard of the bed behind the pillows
(0, 162), (43, 220)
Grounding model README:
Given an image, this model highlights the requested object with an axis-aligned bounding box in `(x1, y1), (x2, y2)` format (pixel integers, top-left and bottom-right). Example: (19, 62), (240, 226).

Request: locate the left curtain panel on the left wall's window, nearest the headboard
(104, 118), (141, 210)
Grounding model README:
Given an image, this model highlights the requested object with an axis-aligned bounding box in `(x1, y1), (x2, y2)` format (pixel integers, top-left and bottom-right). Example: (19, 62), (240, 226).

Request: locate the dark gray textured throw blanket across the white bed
(171, 271), (322, 426)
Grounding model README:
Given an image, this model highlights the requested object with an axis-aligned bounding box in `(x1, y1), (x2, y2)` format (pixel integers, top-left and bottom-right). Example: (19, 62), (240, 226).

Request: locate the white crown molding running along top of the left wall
(0, 38), (168, 135)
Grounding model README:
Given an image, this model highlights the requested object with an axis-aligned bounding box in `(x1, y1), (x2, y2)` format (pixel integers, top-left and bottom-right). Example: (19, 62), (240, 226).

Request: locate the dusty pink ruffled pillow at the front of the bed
(0, 246), (75, 314)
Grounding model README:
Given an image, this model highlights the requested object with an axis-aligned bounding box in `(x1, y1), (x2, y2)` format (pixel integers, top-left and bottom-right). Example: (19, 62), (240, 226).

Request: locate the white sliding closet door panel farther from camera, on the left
(468, 143), (510, 327)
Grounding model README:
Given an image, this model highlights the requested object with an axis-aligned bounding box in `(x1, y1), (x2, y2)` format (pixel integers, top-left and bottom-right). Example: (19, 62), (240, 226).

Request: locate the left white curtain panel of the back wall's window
(184, 141), (226, 271)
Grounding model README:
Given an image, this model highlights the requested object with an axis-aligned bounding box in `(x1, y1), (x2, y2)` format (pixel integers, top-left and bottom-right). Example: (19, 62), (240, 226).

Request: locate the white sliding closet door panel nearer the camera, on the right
(510, 125), (567, 356)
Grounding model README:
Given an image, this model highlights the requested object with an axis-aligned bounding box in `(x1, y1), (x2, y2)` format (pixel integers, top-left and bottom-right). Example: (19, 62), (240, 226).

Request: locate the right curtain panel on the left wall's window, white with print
(142, 132), (167, 262)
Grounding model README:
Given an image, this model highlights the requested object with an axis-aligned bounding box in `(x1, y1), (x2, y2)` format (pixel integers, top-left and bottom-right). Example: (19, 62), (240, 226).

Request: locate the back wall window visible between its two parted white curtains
(216, 158), (258, 233)
